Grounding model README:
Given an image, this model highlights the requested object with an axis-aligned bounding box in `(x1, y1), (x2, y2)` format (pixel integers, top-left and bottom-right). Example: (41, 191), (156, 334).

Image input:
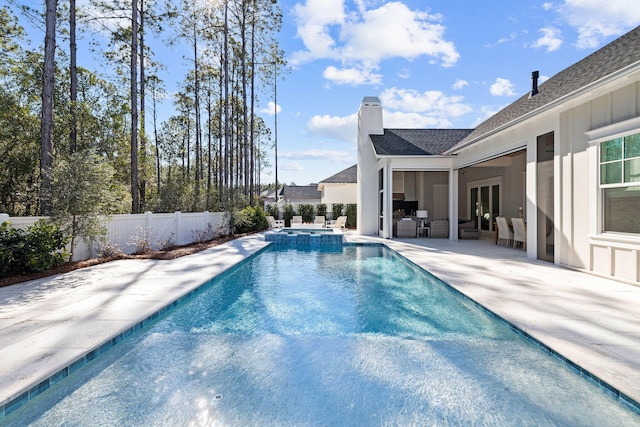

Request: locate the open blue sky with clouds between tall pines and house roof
(272, 0), (640, 185)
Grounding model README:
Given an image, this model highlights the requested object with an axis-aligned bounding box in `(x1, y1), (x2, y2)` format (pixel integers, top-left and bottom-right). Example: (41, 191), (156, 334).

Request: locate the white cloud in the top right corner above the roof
(559, 0), (640, 48)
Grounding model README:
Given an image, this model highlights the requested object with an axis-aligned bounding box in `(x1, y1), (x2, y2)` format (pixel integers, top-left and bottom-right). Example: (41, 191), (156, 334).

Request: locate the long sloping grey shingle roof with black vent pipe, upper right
(449, 27), (640, 152)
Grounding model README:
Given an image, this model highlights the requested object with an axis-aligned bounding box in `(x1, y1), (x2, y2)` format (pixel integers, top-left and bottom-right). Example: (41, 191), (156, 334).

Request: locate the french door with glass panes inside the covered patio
(467, 178), (502, 232)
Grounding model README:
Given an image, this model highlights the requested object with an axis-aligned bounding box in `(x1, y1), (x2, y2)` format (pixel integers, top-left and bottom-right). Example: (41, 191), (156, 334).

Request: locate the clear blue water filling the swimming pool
(5, 246), (640, 426)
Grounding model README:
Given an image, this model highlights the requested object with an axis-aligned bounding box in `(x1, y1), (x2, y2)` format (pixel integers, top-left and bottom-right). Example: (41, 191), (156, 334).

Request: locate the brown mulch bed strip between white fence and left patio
(0, 234), (245, 288)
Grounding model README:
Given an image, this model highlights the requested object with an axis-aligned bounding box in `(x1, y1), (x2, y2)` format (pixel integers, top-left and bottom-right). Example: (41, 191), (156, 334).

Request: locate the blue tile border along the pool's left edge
(0, 245), (270, 421)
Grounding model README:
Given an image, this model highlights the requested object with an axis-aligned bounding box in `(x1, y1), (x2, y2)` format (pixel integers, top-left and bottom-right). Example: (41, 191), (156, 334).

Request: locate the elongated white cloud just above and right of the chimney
(380, 88), (471, 118)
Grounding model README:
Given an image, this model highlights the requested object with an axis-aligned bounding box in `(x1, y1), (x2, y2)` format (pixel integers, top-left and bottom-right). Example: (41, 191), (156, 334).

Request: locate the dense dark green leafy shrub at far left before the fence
(0, 221), (69, 277)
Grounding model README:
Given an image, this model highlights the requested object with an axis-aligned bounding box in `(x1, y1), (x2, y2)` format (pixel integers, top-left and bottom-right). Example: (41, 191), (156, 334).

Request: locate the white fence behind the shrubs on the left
(0, 211), (229, 261)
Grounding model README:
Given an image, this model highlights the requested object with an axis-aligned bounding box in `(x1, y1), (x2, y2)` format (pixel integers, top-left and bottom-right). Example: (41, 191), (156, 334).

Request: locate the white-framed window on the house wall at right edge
(599, 133), (640, 234)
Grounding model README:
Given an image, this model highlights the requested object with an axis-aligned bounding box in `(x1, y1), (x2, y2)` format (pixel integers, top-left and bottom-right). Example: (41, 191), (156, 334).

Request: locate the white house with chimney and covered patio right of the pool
(358, 27), (640, 284)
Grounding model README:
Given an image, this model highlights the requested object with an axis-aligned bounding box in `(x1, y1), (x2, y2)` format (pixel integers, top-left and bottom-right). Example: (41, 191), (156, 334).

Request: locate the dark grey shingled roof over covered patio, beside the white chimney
(369, 129), (473, 156)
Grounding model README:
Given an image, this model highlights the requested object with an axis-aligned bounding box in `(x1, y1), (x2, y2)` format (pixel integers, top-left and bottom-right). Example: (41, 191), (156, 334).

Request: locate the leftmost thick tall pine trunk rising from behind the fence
(40, 0), (58, 215)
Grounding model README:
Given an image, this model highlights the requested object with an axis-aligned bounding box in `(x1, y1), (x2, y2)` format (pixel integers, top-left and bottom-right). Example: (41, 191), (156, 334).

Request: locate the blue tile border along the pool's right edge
(384, 245), (640, 412)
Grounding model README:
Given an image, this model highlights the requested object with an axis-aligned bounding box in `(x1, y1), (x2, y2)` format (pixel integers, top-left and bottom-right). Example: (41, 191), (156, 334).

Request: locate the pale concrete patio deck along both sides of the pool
(0, 233), (640, 420)
